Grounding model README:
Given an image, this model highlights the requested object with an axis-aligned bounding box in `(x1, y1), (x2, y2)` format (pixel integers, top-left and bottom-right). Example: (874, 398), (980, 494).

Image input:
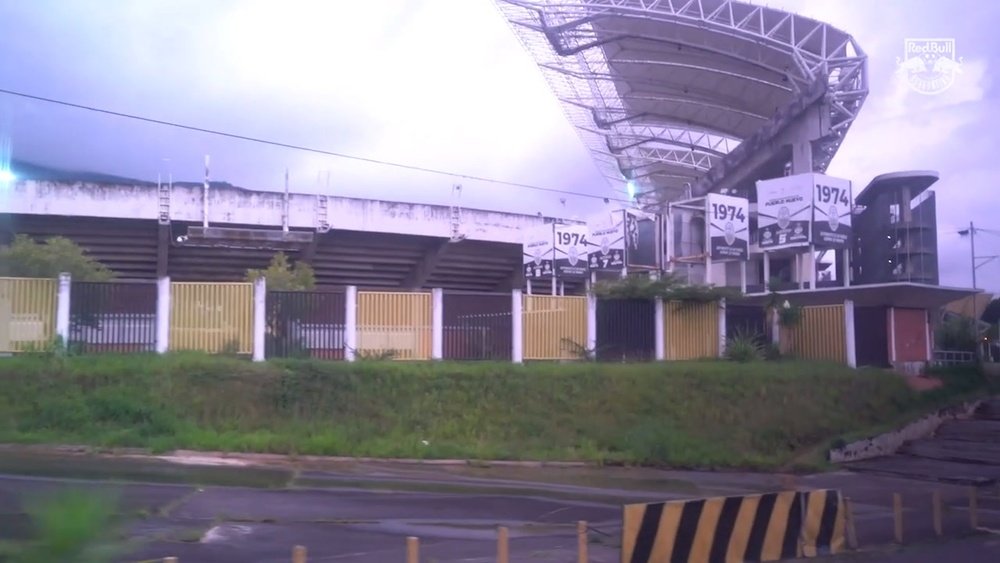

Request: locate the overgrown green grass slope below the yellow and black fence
(0, 354), (984, 469)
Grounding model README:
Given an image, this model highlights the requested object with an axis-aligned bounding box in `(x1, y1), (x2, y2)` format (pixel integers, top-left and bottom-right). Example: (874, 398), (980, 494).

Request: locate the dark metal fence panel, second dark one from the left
(264, 291), (346, 360)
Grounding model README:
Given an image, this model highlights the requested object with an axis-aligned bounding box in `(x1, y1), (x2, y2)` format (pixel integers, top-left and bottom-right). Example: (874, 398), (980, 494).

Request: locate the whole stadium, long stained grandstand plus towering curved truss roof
(0, 0), (969, 370)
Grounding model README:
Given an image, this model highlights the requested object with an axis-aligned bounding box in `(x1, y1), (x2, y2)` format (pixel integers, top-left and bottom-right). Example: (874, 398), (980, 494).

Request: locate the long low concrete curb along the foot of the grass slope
(0, 444), (599, 468)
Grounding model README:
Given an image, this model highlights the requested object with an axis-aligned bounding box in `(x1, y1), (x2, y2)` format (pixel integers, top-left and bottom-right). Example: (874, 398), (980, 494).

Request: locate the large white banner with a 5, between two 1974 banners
(757, 174), (813, 250)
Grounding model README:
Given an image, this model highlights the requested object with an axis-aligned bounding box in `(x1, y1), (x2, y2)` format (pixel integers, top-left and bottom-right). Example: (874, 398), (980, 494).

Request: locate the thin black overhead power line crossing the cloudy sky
(0, 88), (629, 203)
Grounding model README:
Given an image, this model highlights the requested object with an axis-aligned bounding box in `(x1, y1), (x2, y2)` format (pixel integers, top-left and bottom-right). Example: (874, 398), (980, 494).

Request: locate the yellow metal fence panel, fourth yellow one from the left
(522, 295), (587, 360)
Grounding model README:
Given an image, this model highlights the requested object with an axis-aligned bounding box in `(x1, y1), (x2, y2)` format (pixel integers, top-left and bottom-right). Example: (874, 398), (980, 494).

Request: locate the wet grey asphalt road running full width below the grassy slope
(0, 452), (1000, 563)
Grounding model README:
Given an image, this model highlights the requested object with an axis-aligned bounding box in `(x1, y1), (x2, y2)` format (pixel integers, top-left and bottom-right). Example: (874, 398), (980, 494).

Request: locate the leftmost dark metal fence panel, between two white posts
(68, 282), (156, 354)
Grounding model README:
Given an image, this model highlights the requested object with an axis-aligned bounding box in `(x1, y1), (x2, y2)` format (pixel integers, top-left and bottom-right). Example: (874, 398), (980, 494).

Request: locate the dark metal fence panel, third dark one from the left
(442, 292), (513, 361)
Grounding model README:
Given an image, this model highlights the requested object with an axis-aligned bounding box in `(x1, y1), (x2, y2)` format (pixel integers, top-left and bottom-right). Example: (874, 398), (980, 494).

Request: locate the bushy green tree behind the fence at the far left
(0, 235), (114, 281)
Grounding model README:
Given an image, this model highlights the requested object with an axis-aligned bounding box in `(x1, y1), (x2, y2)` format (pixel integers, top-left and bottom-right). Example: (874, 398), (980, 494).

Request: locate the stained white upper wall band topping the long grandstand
(0, 181), (572, 244)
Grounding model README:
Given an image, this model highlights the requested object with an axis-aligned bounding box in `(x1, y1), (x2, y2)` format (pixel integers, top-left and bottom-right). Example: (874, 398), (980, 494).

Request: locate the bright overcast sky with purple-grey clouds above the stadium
(0, 0), (1000, 292)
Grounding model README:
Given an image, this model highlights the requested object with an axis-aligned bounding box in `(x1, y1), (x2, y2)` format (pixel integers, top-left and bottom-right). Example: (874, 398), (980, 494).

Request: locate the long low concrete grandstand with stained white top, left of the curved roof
(0, 163), (575, 291)
